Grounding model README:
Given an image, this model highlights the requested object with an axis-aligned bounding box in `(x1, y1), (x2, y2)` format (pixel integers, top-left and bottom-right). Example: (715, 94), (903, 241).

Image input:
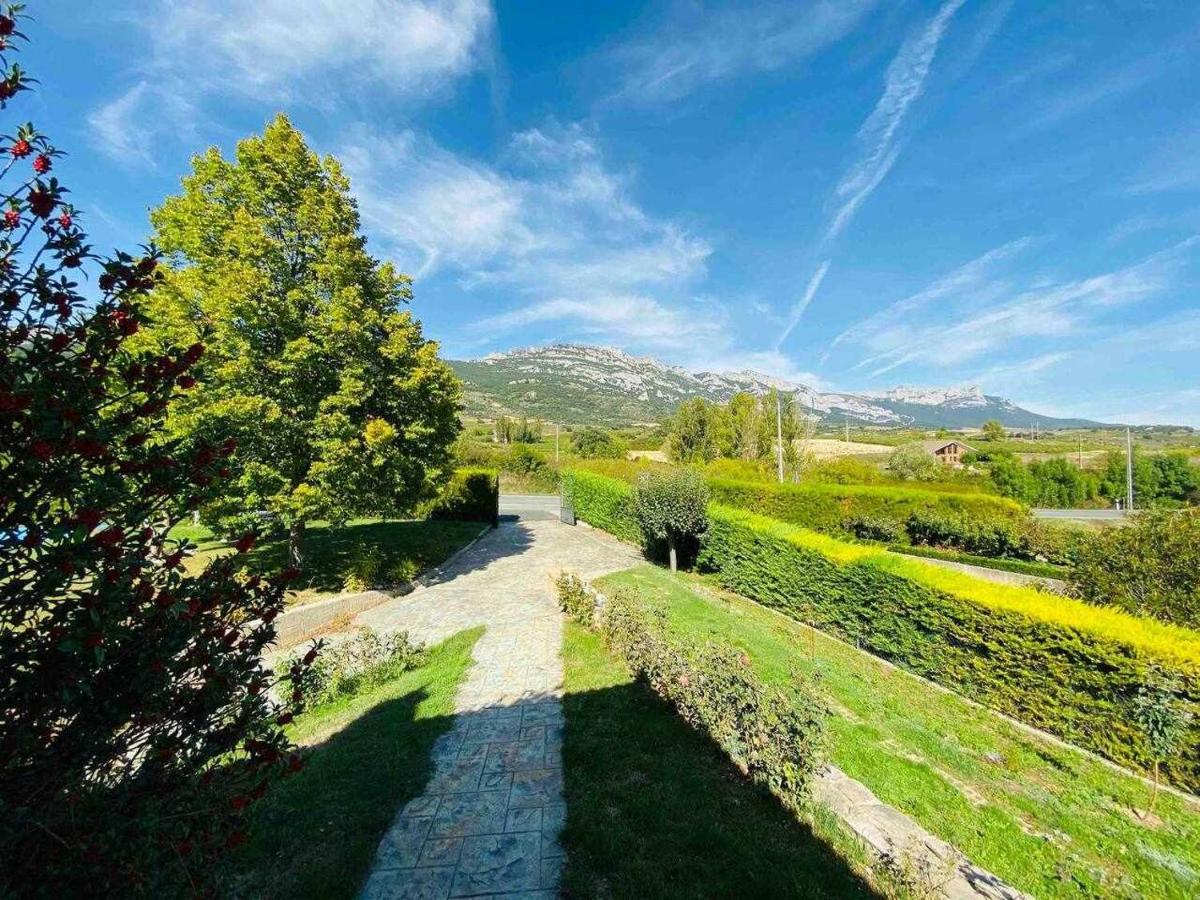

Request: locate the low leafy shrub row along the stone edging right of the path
(558, 575), (828, 811)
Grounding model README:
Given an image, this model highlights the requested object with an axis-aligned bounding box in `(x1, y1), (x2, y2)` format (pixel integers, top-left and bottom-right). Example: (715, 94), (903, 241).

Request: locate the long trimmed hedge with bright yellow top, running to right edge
(700, 505), (1200, 791)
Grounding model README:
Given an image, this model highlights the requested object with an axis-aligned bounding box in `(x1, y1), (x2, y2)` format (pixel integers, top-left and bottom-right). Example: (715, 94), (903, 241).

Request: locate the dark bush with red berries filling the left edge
(0, 6), (311, 896)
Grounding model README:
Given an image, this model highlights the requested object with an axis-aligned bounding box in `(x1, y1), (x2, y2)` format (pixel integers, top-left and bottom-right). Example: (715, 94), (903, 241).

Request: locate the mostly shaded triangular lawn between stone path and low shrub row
(563, 623), (874, 900)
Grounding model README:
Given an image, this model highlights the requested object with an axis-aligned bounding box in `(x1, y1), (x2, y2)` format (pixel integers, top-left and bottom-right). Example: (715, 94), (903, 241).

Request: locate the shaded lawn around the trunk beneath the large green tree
(170, 518), (484, 604)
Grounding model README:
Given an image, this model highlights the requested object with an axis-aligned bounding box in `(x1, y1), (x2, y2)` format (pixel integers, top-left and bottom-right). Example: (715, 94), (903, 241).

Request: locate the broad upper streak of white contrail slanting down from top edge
(826, 0), (965, 240)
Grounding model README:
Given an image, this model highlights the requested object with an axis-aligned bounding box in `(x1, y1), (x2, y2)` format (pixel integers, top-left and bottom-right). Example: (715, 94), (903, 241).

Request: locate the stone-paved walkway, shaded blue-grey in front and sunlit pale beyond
(354, 521), (640, 900)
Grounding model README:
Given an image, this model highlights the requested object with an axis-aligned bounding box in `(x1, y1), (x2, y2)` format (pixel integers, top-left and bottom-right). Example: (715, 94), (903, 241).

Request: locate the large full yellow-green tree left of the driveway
(138, 115), (461, 563)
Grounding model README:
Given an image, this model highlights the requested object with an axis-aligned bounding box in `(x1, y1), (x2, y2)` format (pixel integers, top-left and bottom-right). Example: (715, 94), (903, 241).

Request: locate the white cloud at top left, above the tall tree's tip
(89, 0), (493, 164)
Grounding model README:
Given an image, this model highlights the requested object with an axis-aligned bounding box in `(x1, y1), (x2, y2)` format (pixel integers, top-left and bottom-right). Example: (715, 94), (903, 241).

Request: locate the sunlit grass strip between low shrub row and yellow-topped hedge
(598, 566), (1200, 898)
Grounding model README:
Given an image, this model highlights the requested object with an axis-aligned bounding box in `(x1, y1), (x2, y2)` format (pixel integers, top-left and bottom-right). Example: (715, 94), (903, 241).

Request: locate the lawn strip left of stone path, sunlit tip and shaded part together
(230, 629), (482, 900)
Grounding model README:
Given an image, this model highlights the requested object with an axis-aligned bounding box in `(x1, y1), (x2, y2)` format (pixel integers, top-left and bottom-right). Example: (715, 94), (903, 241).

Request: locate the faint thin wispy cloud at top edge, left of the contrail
(607, 0), (875, 104)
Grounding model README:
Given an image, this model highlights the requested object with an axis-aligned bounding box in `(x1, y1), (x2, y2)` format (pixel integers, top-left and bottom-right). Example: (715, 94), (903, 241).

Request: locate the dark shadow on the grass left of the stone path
(228, 689), (454, 900)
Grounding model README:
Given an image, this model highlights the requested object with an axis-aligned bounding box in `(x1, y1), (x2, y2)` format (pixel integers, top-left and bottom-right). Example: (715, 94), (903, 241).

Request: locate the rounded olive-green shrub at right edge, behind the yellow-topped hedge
(1070, 510), (1200, 628)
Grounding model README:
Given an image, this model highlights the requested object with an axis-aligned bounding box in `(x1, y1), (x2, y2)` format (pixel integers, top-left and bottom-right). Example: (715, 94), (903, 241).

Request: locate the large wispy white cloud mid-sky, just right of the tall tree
(337, 122), (715, 350)
